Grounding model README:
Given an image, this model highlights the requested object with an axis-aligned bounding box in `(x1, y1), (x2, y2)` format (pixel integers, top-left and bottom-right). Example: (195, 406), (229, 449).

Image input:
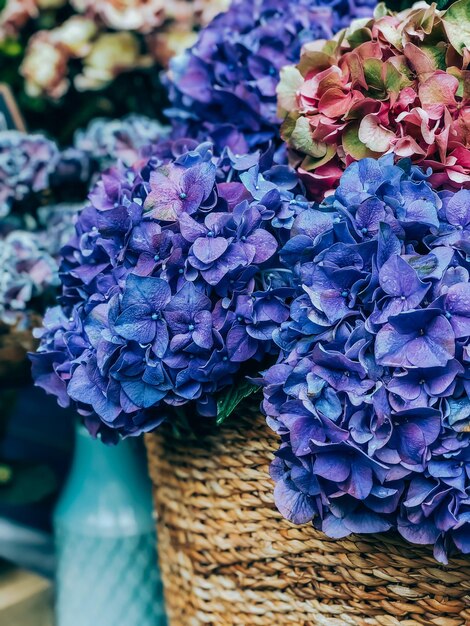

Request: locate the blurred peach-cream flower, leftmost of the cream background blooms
(20, 31), (69, 99)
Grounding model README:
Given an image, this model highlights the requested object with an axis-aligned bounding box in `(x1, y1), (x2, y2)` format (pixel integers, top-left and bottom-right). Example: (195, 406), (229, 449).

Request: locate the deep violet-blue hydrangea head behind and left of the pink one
(165, 0), (376, 153)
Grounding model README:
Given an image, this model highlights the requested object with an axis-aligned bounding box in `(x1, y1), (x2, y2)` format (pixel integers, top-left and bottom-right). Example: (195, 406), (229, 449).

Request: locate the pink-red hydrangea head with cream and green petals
(279, 0), (470, 199)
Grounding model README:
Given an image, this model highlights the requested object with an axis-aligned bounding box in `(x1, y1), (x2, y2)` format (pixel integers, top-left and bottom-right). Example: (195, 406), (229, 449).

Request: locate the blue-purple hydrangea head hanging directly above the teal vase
(32, 142), (307, 436)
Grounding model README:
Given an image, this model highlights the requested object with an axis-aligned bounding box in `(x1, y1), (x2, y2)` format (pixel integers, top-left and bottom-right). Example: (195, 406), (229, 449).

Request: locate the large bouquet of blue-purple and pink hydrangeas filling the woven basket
(26, 0), (470, 562)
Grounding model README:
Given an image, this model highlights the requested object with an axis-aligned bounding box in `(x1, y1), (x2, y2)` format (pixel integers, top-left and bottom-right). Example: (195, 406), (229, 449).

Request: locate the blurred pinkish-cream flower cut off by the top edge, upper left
(71, 0), (165, 33)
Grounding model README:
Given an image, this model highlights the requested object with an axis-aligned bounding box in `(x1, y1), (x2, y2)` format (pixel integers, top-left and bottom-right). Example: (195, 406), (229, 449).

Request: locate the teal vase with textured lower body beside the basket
(54, 426), (166, 626)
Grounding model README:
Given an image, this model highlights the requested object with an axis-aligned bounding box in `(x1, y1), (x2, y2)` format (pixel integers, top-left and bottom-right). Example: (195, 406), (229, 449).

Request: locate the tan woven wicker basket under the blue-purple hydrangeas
(146, 417), (470, 626)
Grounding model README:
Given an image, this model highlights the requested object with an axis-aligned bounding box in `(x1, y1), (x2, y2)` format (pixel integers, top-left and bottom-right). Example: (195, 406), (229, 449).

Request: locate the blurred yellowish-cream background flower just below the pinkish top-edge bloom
(74, 32), (152, 91)
